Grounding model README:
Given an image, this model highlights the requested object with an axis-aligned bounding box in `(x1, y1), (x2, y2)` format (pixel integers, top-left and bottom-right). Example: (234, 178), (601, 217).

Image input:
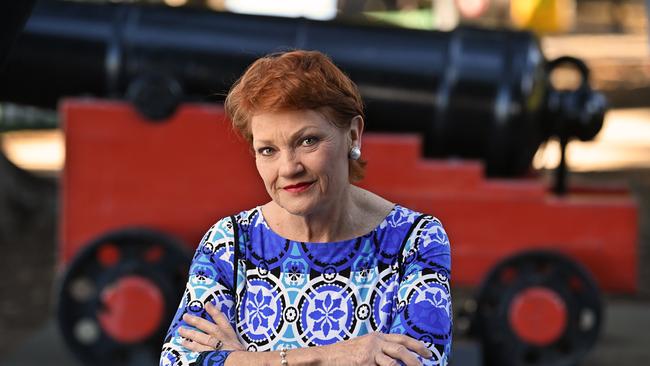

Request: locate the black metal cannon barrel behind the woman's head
(0, 1), (606, 176)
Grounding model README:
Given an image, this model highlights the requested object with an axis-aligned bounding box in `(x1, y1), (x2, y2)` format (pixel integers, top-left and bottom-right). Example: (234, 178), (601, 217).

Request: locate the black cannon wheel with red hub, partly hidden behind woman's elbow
(57, 229), (190, 365)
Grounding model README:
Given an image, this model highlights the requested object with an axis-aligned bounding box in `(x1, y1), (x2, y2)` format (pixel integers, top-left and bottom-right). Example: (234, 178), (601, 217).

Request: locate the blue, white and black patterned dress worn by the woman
(160, 205), (451, 365)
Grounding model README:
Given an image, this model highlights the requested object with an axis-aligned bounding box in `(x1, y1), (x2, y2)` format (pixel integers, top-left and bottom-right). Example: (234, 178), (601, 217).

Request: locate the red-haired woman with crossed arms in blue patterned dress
(161, 51), (451, 366)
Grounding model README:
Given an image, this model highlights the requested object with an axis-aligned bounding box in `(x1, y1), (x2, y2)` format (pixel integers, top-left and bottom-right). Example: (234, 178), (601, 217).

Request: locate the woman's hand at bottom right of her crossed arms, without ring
(324, 332), (433, 366)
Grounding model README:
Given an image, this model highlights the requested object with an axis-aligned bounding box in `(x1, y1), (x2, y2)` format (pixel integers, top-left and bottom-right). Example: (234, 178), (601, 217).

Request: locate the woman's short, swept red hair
(225, 50), (366, 182)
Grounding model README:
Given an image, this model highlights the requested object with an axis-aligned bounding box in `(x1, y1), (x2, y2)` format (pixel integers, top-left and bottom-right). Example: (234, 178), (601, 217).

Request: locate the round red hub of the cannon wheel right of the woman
(508, 286), (567, 346)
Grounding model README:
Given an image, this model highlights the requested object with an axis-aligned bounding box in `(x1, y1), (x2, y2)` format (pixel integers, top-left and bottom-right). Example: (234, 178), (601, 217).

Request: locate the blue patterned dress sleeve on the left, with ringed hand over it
(160, 217), (236, 366)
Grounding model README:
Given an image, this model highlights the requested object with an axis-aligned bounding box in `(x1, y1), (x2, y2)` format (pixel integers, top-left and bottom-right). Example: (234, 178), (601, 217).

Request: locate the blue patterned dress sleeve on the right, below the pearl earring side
(389, 216), (452, 366)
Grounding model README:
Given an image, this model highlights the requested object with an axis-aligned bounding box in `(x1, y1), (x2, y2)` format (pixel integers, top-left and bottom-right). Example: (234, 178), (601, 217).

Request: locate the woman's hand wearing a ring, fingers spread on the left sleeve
(178, 302), (245, 352)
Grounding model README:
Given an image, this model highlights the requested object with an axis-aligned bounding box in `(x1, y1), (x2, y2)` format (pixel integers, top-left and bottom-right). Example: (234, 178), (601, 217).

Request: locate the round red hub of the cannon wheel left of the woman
(98, 276), (165, 343)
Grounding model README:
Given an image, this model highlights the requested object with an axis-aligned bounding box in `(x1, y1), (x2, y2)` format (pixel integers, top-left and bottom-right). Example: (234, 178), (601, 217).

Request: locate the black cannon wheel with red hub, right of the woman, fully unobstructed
(472, 251), (602, 366)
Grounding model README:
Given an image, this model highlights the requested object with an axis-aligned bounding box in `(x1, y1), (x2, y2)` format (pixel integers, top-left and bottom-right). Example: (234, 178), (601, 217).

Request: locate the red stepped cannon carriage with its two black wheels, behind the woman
(59, 99), (637, 365)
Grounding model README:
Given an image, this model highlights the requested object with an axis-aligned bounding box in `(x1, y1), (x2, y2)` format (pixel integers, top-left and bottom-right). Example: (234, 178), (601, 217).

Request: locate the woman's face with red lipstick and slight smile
(251, 110), (360, 216)
